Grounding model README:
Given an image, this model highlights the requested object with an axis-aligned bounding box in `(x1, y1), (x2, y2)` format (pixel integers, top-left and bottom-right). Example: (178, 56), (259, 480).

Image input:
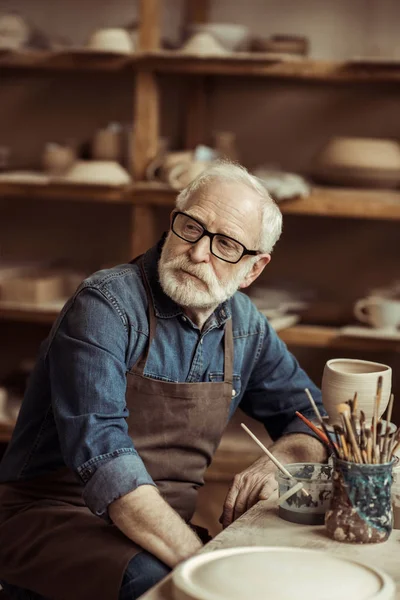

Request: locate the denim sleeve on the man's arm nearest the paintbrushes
(240, 320), (326, 441)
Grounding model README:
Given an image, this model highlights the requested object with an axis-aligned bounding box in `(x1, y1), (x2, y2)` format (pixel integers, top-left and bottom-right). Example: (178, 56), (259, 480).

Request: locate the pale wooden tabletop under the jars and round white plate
(140, 497), (400, 600)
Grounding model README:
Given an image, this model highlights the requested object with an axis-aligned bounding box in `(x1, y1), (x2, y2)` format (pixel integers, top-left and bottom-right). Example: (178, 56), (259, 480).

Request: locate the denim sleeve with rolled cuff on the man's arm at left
(46, 288), (155, 518)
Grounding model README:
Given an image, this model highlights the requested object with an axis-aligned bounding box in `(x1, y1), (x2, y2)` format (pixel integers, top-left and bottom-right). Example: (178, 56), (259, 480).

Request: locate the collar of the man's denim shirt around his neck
(143, 233), (232, 327)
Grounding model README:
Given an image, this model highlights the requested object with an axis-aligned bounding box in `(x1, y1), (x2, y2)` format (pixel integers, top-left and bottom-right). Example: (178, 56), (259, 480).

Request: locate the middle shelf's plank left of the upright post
(0, 181), (131, 203)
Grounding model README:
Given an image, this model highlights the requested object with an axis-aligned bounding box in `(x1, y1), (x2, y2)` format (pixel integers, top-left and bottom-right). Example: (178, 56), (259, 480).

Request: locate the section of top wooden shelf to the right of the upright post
(139, 50), (400, 83)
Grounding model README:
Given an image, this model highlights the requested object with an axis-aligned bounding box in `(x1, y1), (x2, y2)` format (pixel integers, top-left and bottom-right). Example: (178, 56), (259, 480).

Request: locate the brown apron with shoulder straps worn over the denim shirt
(0, 267), (233, 600)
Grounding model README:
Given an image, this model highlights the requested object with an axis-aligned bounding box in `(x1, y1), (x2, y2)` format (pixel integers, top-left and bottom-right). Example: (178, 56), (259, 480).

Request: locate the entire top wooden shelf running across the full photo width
(0, 49), (400, 83)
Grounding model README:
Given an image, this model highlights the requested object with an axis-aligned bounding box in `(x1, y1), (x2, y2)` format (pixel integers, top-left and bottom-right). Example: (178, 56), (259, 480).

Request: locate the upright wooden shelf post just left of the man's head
(130, 0), (161, 257)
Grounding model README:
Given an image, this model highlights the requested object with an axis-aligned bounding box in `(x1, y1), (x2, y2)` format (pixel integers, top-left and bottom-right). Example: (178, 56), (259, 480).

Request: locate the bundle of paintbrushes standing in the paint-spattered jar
(296, 377), (400, 464)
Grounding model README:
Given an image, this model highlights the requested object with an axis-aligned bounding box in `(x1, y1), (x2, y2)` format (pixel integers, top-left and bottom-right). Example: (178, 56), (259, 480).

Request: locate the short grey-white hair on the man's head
(175, 160), (282, 253)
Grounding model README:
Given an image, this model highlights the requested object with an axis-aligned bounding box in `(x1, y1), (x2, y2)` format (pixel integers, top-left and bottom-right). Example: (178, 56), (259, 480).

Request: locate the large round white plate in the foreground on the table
(172, 546), (395, 600)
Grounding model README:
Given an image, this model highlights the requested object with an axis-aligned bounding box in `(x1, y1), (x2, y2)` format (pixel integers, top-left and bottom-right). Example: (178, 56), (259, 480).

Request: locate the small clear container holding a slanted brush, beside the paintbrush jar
(275, 463), (332, 525)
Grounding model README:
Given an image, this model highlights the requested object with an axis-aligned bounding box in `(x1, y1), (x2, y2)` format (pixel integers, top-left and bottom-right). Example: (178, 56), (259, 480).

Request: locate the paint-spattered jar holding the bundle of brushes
(325, 458), (393, 544)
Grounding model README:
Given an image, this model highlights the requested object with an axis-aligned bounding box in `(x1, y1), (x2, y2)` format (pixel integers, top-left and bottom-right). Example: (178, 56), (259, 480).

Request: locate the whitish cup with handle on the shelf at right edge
(354, 296), (400, 331)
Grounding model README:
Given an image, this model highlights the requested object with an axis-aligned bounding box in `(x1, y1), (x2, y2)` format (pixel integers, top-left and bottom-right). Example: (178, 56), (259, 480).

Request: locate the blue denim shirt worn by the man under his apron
(0, 239), (323, 518)
